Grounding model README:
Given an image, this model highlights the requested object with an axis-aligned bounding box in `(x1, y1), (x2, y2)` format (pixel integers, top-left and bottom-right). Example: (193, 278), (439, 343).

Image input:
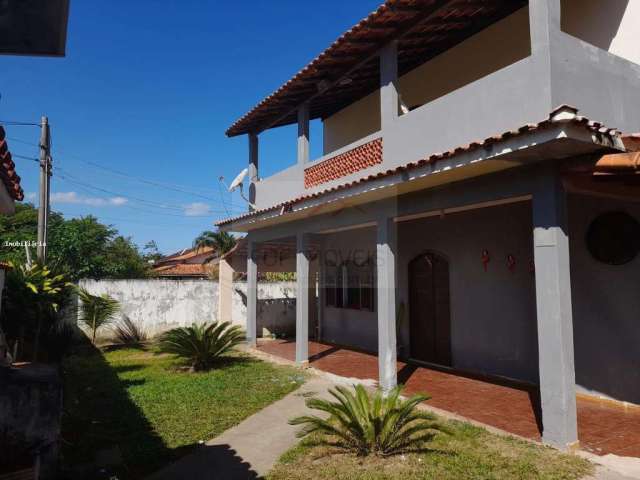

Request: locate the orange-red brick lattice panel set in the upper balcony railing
(304, 138), (382, 188)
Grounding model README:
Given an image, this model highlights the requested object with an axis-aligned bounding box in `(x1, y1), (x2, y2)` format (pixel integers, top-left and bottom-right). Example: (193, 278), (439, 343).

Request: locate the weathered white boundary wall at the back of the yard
(80, 279), (295, 339)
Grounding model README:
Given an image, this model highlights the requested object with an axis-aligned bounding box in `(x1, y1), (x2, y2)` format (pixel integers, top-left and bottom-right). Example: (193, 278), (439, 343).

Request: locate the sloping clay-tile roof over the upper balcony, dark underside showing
(226, 0), (527, 137)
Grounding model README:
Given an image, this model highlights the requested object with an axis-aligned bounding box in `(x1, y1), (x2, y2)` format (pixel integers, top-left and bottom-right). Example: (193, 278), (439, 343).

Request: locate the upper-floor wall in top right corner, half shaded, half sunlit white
(562, 0), (640, 64)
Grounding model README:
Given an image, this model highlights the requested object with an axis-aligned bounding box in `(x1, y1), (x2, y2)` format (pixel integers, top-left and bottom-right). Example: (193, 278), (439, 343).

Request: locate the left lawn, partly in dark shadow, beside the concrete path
(62, 348), (304, 479)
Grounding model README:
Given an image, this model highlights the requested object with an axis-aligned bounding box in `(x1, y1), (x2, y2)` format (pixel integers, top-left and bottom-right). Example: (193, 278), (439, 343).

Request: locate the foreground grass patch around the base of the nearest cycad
(267, 422), (593, 480)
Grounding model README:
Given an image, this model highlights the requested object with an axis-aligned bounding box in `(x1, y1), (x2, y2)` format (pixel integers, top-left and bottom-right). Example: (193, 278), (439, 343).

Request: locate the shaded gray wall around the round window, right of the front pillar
(569, 195), (640, 403)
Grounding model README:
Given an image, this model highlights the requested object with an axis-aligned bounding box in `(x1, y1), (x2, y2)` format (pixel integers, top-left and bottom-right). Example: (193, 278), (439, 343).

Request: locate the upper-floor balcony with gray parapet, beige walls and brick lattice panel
(248, 0), (640, 212)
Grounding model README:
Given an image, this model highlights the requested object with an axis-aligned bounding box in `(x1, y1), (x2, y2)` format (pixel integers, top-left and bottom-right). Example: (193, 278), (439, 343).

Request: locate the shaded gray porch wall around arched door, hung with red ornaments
(398, 202), (538, 382)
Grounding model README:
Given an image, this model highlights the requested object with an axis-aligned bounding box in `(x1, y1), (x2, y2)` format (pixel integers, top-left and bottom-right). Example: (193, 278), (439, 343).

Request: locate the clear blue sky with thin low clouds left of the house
(0, 0), (379, 253)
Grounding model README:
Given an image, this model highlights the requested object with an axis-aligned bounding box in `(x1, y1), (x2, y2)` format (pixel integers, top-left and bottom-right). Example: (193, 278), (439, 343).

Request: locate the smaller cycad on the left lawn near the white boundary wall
(158, 322), (244, 371)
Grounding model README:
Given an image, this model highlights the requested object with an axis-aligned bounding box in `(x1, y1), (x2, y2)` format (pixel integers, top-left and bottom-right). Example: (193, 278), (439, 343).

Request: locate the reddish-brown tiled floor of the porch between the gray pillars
(258, 340), (640, 457)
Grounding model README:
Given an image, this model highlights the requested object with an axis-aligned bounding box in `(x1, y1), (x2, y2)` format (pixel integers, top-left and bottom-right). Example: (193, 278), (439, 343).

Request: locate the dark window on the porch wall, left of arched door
(325, 258), (375, 312)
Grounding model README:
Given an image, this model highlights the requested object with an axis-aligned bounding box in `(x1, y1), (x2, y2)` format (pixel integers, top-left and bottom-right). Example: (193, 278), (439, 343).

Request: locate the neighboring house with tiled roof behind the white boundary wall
(152, 247), (218, 279)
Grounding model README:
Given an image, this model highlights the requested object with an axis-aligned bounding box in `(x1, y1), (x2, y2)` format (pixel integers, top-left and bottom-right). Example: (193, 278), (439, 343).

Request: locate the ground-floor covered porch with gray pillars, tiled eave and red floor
(219, 107), (640, 455)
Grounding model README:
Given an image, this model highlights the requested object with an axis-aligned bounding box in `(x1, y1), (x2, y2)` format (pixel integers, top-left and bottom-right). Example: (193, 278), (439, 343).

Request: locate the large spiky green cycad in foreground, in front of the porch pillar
(289, 385), (448, 456)
